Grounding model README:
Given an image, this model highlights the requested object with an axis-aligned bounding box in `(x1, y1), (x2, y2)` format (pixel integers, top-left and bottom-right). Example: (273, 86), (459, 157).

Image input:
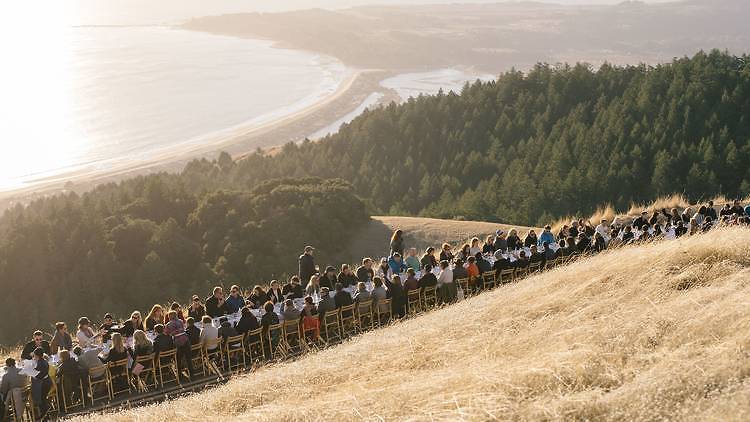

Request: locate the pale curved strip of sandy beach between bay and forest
(0, 69), (398, 211)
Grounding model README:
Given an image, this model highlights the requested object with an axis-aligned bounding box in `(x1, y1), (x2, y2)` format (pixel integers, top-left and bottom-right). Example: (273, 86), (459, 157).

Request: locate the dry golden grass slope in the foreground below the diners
(80, 228), (750, 421)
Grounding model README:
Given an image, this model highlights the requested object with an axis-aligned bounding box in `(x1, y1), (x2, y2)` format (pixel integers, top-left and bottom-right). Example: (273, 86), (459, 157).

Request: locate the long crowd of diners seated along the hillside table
(0, 201), (750, 415)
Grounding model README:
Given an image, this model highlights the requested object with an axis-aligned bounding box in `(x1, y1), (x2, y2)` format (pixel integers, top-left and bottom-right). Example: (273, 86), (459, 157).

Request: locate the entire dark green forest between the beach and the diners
(0, 51), (750, 343)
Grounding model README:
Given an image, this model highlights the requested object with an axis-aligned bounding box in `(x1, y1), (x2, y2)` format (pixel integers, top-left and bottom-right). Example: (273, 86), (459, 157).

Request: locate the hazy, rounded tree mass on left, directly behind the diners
(0, 174), (368, 344)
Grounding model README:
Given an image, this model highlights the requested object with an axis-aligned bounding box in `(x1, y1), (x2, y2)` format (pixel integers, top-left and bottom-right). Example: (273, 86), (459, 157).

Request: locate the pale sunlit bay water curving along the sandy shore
(0, 27), (349, 189)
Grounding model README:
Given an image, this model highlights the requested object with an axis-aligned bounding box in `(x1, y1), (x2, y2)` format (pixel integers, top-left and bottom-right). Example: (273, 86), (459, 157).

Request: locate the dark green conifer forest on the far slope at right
(183, 51), (750, 225)
